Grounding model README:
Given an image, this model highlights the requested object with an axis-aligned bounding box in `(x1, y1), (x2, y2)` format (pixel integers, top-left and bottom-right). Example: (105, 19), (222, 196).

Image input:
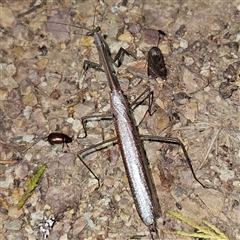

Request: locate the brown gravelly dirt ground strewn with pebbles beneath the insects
(0, 0), (240, 240)
